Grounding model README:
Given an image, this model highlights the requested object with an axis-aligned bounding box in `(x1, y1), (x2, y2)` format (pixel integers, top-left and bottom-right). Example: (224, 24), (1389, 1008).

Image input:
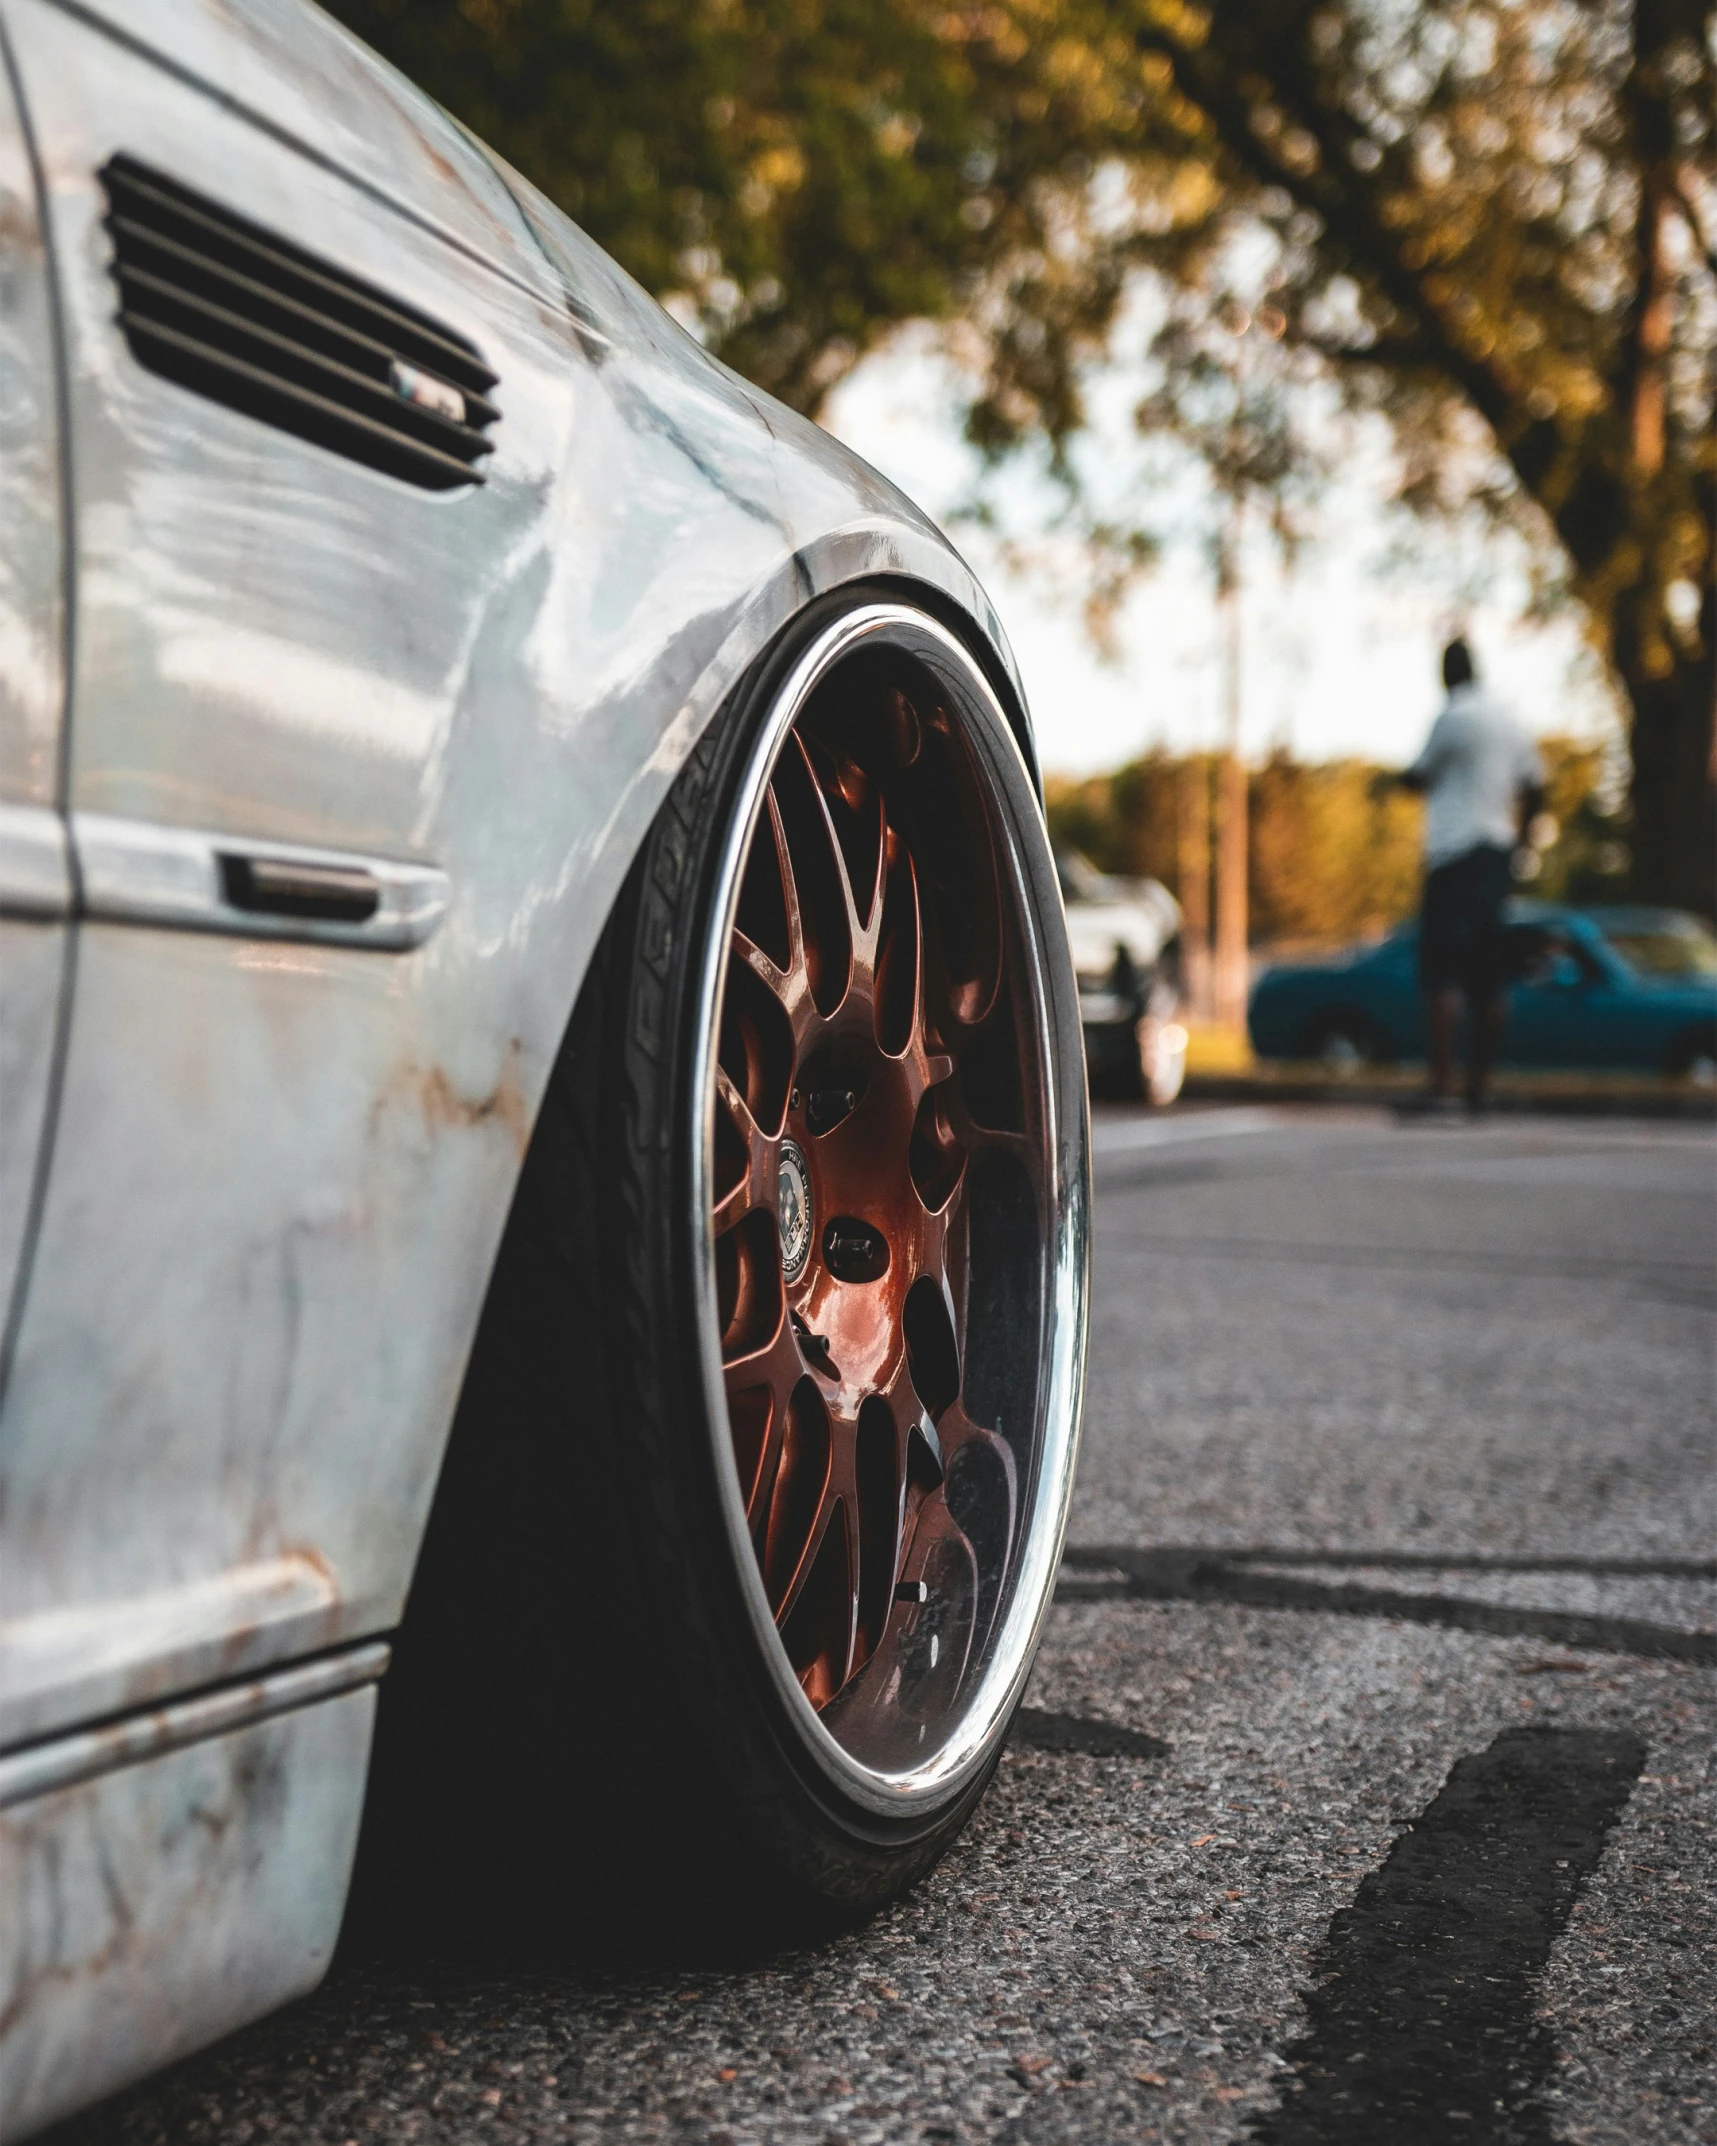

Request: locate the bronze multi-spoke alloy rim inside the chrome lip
(708, 600), (1086, 1773)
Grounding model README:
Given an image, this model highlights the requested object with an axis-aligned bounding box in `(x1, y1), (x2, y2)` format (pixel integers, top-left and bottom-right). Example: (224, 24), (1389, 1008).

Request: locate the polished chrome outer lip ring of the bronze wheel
(687, 603), (1090, 1818)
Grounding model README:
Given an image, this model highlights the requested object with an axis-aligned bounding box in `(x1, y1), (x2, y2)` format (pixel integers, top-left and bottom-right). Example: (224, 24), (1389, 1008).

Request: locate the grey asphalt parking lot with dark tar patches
(58, 1109), (1717, 2146)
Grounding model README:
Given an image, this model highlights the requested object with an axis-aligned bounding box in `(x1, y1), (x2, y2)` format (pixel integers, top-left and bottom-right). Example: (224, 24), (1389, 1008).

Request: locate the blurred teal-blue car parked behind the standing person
(1249, 901), (1717, 1079)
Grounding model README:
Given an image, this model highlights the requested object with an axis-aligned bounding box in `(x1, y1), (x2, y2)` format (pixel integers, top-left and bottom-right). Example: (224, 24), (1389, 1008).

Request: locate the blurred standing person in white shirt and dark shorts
(1384, 640), (1543, 1116)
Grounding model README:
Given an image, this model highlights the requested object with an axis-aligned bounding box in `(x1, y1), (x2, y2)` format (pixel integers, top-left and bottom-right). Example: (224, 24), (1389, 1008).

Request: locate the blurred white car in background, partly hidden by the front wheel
(1056, 850), (1187, 1103)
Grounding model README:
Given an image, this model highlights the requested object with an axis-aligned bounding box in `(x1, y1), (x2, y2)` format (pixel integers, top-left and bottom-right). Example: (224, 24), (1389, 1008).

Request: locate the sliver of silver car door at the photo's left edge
(0, 33), (71, 1330)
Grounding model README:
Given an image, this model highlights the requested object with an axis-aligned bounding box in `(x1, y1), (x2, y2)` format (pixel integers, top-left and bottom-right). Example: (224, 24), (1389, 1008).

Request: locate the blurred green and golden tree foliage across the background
(333, 0), (1717, 914)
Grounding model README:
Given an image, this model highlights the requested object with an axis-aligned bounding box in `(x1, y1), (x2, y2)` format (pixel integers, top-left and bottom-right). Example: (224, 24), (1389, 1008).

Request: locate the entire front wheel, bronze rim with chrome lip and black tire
(356, 601), (1088, 1942)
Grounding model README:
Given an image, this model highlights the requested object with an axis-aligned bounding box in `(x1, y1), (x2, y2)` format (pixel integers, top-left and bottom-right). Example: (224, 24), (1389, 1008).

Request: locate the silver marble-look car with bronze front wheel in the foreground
(0, 0), (1088, 2137)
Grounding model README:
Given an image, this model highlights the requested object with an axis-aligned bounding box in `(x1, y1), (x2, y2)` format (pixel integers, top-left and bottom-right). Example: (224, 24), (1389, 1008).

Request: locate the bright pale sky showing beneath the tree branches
(822, 330), (1616, 775)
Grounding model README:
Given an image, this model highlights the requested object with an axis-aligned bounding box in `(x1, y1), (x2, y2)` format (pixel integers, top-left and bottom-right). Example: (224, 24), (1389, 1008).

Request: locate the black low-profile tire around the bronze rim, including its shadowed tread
(352, 597), (1084, 1957)
